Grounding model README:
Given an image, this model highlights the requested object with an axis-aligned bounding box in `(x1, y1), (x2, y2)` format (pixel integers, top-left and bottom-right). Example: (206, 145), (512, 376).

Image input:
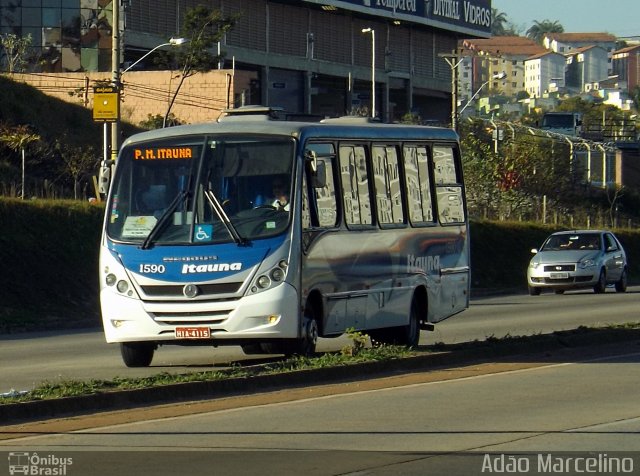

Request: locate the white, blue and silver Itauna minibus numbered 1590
(99, 110), (470, 367)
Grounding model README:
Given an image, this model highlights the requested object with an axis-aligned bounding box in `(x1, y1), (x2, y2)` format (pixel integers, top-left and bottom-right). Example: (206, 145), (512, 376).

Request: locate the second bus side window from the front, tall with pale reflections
(339, 145), (373, 225)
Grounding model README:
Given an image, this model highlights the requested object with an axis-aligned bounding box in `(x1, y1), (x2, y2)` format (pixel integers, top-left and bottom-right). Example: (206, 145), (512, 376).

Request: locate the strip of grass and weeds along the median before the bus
(0, 323), (640, 405)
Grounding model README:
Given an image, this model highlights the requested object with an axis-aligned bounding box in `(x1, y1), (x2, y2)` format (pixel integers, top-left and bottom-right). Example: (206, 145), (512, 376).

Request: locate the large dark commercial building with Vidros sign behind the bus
(0, 0), (491, 121)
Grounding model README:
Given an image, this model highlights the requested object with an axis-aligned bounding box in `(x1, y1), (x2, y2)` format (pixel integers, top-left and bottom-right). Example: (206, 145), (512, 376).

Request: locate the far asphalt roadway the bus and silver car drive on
(0, 286), (640, 393)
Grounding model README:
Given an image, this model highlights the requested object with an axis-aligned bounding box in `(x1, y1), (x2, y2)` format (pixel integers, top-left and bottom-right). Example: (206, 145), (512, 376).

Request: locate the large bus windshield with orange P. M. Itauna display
(107, 135), (295, 248)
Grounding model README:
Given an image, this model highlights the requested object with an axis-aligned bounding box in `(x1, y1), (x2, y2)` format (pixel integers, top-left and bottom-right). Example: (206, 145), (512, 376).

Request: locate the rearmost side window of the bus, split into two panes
(433, 146), (465, 224)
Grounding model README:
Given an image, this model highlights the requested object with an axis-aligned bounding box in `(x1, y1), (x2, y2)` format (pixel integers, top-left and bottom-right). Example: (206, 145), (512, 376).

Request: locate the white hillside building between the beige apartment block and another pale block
(524, 51), (567, 98)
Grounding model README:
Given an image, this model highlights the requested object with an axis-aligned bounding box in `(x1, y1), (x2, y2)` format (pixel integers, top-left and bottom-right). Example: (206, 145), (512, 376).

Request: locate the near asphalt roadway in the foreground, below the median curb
(0, 342), (640, 476)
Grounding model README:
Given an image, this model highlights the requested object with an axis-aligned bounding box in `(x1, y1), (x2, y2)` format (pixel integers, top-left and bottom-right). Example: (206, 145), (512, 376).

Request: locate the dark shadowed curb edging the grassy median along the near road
(0, 328), (640, 423)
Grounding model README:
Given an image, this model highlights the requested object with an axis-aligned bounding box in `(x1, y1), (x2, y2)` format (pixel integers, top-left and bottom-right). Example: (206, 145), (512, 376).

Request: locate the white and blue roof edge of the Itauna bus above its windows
(123, 116), (458, 146)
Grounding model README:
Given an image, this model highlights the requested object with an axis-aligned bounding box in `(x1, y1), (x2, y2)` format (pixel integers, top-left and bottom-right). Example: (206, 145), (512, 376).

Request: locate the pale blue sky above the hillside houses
(491, 0), (640, 37)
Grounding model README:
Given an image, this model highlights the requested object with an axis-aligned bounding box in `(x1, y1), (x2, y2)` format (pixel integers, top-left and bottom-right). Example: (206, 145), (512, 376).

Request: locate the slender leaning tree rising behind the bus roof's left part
(163, 5), (237, 127)
